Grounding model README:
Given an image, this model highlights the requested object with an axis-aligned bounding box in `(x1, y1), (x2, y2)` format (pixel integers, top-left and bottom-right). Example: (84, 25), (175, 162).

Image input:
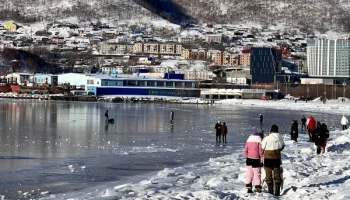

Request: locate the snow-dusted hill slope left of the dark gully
(0, 0), (157, 22)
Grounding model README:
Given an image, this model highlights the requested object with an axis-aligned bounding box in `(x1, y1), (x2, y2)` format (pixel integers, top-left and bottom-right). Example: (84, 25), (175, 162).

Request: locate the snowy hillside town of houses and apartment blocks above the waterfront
(0, 21), (350, 99)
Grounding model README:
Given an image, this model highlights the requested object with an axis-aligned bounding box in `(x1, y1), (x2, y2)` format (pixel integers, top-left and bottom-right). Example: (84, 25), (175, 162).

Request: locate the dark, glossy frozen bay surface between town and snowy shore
(0, 99), (339, 198)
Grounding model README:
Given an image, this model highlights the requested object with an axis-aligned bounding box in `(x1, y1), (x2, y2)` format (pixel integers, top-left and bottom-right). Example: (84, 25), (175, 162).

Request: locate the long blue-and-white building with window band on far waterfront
(86, 74), (200, 98)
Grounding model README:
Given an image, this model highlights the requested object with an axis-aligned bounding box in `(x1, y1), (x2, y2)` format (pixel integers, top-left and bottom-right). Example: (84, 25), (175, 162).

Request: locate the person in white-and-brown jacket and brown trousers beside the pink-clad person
(261, 124), (284, 196)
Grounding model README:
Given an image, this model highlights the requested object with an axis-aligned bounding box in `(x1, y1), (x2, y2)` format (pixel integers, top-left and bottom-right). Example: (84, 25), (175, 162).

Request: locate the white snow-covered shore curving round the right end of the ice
(39, 99), (350, 200)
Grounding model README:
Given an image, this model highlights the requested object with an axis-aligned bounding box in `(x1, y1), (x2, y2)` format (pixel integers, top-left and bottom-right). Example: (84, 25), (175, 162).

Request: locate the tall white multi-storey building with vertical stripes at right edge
(307, 39), (350, 78)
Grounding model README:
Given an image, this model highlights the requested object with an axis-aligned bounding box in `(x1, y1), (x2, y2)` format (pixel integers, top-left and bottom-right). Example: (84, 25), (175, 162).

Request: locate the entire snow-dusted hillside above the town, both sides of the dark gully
(0, 0), (350, 33)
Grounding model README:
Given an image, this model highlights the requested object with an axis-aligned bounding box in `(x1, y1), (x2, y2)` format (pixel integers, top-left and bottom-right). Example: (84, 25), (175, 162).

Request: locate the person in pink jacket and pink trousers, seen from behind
(245, 129), (264, 193)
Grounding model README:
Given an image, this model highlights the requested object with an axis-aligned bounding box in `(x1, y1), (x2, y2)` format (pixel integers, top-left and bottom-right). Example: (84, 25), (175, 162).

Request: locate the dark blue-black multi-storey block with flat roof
(250, 47), (282, 84)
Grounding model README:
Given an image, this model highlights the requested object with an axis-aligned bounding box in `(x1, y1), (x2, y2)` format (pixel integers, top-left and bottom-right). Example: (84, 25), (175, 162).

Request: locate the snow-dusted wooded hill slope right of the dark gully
(174, 0), (350, 33)
